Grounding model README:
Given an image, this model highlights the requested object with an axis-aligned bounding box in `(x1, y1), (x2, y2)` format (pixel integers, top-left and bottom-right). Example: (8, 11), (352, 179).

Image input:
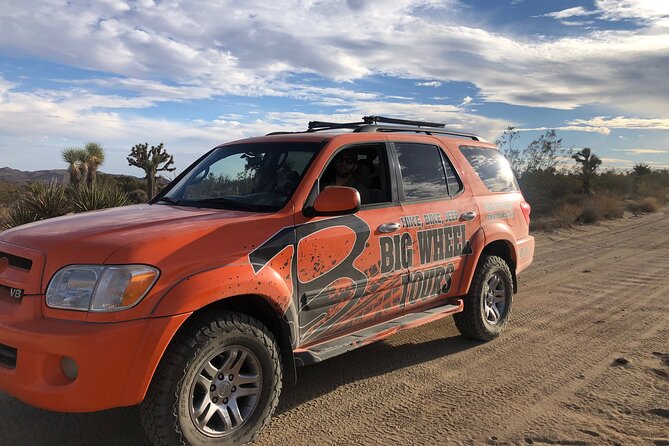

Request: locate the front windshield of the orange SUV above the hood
(156, 142), (320, 212)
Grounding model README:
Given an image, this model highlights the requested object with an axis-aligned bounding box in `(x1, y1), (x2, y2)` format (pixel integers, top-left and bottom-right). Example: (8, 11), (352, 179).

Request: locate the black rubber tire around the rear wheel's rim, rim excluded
(453, 255), (513, 341)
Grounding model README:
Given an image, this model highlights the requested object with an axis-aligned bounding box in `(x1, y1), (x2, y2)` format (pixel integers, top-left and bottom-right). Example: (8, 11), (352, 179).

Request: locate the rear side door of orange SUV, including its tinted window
(392, 140), (480, 311)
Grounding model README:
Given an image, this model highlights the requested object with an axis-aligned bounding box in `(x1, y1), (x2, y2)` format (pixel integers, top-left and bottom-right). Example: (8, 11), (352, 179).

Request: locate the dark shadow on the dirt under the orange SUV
(0, 320), (481, 446)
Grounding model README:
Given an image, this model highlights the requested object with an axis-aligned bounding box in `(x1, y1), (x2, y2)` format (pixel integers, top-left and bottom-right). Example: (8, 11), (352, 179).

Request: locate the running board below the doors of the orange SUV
(294, 299), (463, 366)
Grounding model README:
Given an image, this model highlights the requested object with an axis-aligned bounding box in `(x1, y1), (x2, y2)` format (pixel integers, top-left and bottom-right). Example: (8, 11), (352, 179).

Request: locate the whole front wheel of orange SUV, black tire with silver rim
(140, 312), (282, 446)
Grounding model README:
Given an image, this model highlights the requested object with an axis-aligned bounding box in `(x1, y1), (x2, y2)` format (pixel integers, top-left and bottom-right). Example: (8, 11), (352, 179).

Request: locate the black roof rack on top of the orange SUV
(282, 116), (480, 141)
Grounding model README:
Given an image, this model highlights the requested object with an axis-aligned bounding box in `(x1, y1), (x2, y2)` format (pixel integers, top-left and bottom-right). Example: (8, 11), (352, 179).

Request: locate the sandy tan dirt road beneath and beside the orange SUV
(0, 211), (669, 446)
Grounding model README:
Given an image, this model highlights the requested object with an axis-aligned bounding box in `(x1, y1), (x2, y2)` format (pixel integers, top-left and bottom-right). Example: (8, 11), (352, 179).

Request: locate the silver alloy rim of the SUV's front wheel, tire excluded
(188, 346), (262, 437)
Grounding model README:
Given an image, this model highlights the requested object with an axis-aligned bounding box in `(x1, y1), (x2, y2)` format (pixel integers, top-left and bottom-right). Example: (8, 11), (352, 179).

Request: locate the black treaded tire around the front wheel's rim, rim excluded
(140, 311), (283, 446)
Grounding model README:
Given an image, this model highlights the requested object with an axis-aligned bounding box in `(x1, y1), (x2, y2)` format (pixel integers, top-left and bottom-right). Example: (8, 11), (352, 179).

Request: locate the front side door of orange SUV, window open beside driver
(296, 141), (410, 345)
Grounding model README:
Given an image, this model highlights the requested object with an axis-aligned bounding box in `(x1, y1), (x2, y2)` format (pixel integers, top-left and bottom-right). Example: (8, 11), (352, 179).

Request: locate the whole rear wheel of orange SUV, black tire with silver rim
(453, 255), (513, 341)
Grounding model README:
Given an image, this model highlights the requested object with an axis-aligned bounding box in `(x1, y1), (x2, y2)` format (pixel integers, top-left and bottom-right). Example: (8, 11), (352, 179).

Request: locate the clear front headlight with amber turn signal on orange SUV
(46, 265), (159, 311)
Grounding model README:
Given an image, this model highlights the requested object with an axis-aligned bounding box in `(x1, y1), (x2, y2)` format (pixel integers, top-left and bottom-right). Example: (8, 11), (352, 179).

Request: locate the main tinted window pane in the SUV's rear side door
(395, 143), (448, 201)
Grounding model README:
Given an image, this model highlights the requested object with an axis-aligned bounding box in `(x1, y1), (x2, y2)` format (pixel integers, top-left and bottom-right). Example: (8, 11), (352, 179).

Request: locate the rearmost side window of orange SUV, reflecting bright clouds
(460, 146), (518, 192)
